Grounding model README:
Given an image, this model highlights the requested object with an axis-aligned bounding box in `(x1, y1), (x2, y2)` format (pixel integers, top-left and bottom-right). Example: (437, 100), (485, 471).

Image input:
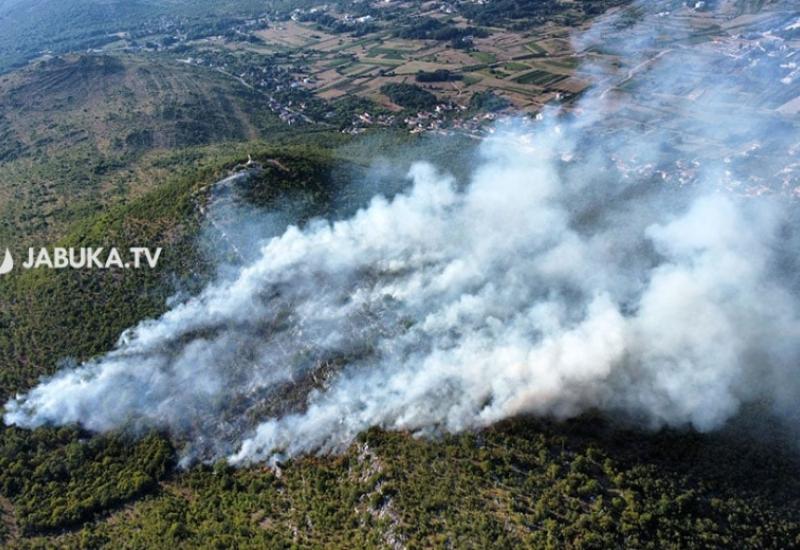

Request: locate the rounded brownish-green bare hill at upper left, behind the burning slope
(0, 55), (283, 245)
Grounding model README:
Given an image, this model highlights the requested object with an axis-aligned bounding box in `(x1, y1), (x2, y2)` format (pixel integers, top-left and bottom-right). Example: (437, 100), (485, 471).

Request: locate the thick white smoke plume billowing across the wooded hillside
(4, 0), (800, 464)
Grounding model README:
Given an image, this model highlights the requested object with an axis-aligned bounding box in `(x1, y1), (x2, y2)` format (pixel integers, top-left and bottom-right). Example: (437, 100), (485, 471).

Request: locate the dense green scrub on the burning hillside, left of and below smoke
(0, 135), (800, 548)
